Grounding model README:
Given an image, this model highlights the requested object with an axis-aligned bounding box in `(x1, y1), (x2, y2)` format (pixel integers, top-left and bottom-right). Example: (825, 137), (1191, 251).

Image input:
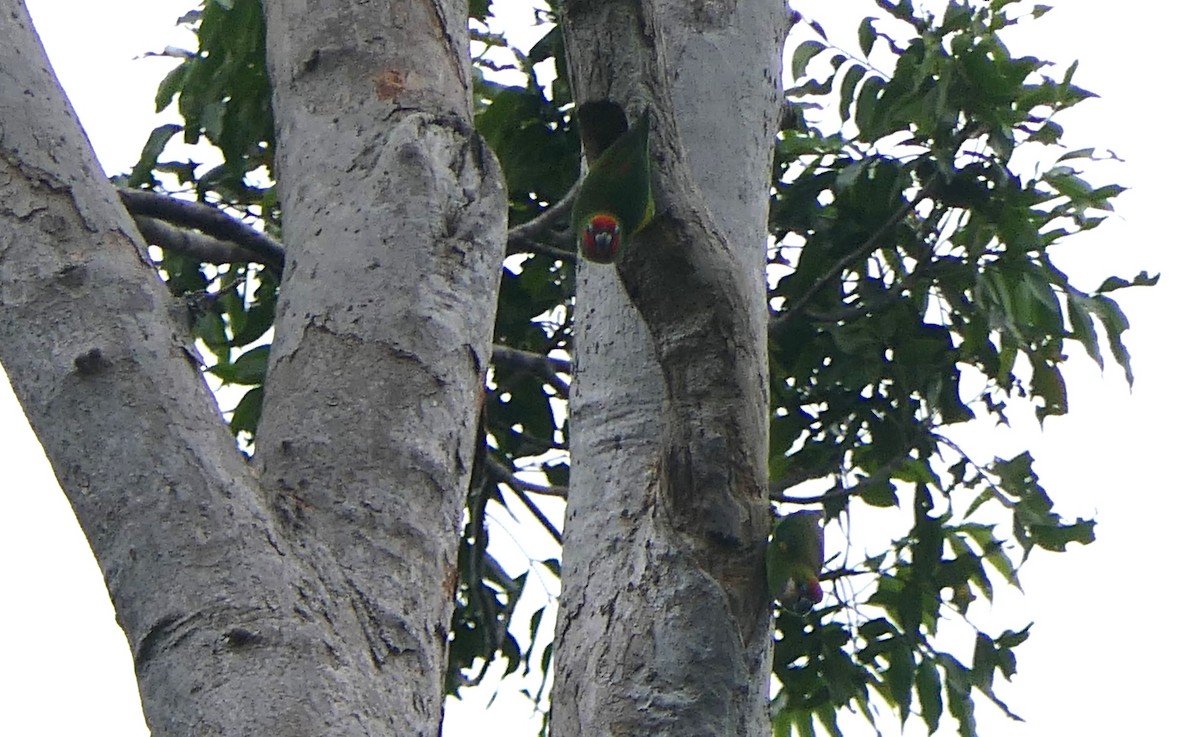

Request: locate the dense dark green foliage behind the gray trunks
(122, 0), (1153, 735)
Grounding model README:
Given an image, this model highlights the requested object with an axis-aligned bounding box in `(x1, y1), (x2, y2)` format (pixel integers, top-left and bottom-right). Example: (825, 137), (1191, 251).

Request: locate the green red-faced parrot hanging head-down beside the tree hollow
(571, 109), (654, 264)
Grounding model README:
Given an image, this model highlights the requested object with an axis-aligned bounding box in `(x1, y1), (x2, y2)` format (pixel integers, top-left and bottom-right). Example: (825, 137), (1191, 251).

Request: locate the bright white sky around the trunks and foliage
(0, 0), (1200, 737)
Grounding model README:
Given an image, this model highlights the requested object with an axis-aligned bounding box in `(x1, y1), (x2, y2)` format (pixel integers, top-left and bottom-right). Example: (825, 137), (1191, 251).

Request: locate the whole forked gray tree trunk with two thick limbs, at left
(0, 0), (506, 737)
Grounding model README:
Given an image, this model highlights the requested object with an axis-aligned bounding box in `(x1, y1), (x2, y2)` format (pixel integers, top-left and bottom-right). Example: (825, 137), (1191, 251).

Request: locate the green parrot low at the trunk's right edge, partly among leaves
(767, 511), (824, 615)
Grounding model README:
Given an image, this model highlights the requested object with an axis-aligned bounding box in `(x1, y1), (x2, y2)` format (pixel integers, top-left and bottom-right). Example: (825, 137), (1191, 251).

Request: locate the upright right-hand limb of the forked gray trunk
(256, 0), (508, 736)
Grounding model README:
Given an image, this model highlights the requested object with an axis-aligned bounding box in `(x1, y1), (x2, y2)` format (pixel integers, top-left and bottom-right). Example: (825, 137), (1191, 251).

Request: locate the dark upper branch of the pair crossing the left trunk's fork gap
(116, 187), (284, 271)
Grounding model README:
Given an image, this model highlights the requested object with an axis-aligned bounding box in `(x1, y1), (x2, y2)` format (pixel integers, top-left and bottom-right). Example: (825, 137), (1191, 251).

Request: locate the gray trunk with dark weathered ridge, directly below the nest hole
(552, 0), (785, 737)
